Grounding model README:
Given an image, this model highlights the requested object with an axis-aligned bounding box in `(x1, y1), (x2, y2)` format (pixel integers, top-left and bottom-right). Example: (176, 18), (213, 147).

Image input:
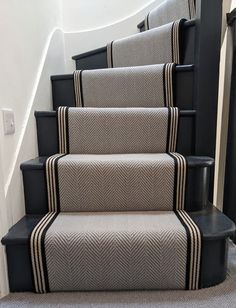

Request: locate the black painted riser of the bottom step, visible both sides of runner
(6, 239), (227, 292)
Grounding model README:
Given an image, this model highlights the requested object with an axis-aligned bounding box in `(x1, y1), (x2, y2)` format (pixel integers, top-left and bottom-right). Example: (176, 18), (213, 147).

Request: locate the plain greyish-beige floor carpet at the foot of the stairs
(0, 245), (236, 308)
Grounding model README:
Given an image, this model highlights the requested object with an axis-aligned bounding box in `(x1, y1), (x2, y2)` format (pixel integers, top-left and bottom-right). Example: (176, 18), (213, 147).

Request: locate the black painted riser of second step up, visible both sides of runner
(21, 157), (213, 214)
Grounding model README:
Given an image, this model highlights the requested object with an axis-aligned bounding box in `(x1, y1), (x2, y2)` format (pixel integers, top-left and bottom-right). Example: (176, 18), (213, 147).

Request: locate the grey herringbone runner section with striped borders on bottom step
(31, 211), (201, 293)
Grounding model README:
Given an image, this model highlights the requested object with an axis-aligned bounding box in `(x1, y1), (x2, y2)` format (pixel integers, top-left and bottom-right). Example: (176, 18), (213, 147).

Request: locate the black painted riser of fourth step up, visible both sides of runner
(51, 65), (194, 110)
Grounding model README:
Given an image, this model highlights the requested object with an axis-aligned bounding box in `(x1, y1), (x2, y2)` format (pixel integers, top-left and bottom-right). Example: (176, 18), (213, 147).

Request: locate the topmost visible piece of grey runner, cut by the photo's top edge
(145, 0), (196, 30)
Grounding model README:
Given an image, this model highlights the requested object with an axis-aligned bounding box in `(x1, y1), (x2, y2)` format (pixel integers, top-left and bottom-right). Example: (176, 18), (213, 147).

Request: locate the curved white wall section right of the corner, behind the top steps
(62, 0), (163, 73)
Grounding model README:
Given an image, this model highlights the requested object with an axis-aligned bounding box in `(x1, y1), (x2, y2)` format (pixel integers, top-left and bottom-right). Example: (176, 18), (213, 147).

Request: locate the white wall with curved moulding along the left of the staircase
(0, 0), (161, 295)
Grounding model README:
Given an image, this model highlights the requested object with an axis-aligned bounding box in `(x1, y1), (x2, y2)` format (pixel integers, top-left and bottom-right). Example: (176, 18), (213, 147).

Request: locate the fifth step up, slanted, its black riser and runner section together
(72, 19), (195, 70)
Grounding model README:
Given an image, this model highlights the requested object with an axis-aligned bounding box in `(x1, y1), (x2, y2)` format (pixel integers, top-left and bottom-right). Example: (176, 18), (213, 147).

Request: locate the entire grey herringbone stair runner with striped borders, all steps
(1, 0), (234, 293)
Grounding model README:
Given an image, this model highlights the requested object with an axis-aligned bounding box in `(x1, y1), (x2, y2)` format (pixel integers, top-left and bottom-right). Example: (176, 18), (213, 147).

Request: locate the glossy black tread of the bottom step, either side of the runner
(2, 206), (235, 245)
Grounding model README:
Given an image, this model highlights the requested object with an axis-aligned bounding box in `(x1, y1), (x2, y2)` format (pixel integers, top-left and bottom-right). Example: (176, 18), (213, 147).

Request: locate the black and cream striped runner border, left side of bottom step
(30, 212), (58, 293)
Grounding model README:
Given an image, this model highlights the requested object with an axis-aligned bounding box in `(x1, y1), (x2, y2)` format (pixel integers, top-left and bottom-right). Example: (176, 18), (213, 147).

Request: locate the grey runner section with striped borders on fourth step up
(74, 64), (174, 107)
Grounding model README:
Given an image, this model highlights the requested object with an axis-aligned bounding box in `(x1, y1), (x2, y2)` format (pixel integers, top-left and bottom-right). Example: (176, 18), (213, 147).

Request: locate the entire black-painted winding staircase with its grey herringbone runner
(2, 0), (235, 293)
